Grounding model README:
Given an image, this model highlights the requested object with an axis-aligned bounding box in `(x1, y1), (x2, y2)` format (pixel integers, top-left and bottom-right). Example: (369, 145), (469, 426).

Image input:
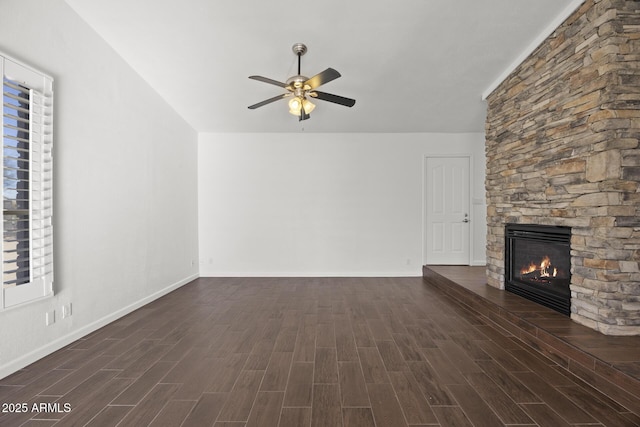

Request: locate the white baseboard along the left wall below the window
(0, 274), (200, 379)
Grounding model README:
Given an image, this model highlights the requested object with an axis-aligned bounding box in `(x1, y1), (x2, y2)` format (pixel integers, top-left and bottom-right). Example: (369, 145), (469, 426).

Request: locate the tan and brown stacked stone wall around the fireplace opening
(486, 0), (640, 335)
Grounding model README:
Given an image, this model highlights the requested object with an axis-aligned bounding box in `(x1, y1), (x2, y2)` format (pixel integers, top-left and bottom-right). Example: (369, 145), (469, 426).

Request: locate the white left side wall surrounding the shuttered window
(0, 0), (198, 377)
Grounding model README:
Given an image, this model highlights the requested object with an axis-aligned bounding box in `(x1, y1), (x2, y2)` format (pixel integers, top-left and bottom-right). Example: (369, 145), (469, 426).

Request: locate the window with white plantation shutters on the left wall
(0, 56), (53, 309)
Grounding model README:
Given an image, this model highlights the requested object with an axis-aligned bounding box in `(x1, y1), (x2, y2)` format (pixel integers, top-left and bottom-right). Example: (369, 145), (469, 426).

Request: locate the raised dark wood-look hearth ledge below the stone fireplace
(422, 265), (640, 416)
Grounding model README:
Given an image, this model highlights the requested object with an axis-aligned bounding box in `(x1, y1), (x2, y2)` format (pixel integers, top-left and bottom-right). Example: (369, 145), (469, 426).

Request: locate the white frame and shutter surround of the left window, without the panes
(0, 52), (53, 311)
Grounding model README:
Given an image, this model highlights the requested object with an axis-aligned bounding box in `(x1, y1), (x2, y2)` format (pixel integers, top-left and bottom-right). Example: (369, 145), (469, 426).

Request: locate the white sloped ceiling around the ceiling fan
(66, 0), (580, 132)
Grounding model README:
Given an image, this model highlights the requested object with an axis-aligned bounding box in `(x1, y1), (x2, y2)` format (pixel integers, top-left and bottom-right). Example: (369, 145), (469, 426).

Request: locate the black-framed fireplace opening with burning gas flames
(505, 224), (571, 315)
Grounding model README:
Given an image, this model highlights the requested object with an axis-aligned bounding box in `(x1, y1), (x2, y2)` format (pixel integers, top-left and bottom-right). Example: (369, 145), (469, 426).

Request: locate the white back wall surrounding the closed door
(198, 132), (486, 276)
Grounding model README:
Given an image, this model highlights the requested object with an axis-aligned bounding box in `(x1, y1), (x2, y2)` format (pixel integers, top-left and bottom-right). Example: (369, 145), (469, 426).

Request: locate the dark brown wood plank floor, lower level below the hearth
(0, 277), (640, 427)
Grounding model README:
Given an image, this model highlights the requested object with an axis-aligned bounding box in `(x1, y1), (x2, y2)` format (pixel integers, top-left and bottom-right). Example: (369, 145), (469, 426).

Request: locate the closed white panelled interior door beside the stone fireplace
(425, 157), (470, 265)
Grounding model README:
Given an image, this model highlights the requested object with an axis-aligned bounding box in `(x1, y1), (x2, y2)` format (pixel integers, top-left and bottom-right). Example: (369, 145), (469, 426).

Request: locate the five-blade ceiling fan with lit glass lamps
(249, 43), (356, 120)
